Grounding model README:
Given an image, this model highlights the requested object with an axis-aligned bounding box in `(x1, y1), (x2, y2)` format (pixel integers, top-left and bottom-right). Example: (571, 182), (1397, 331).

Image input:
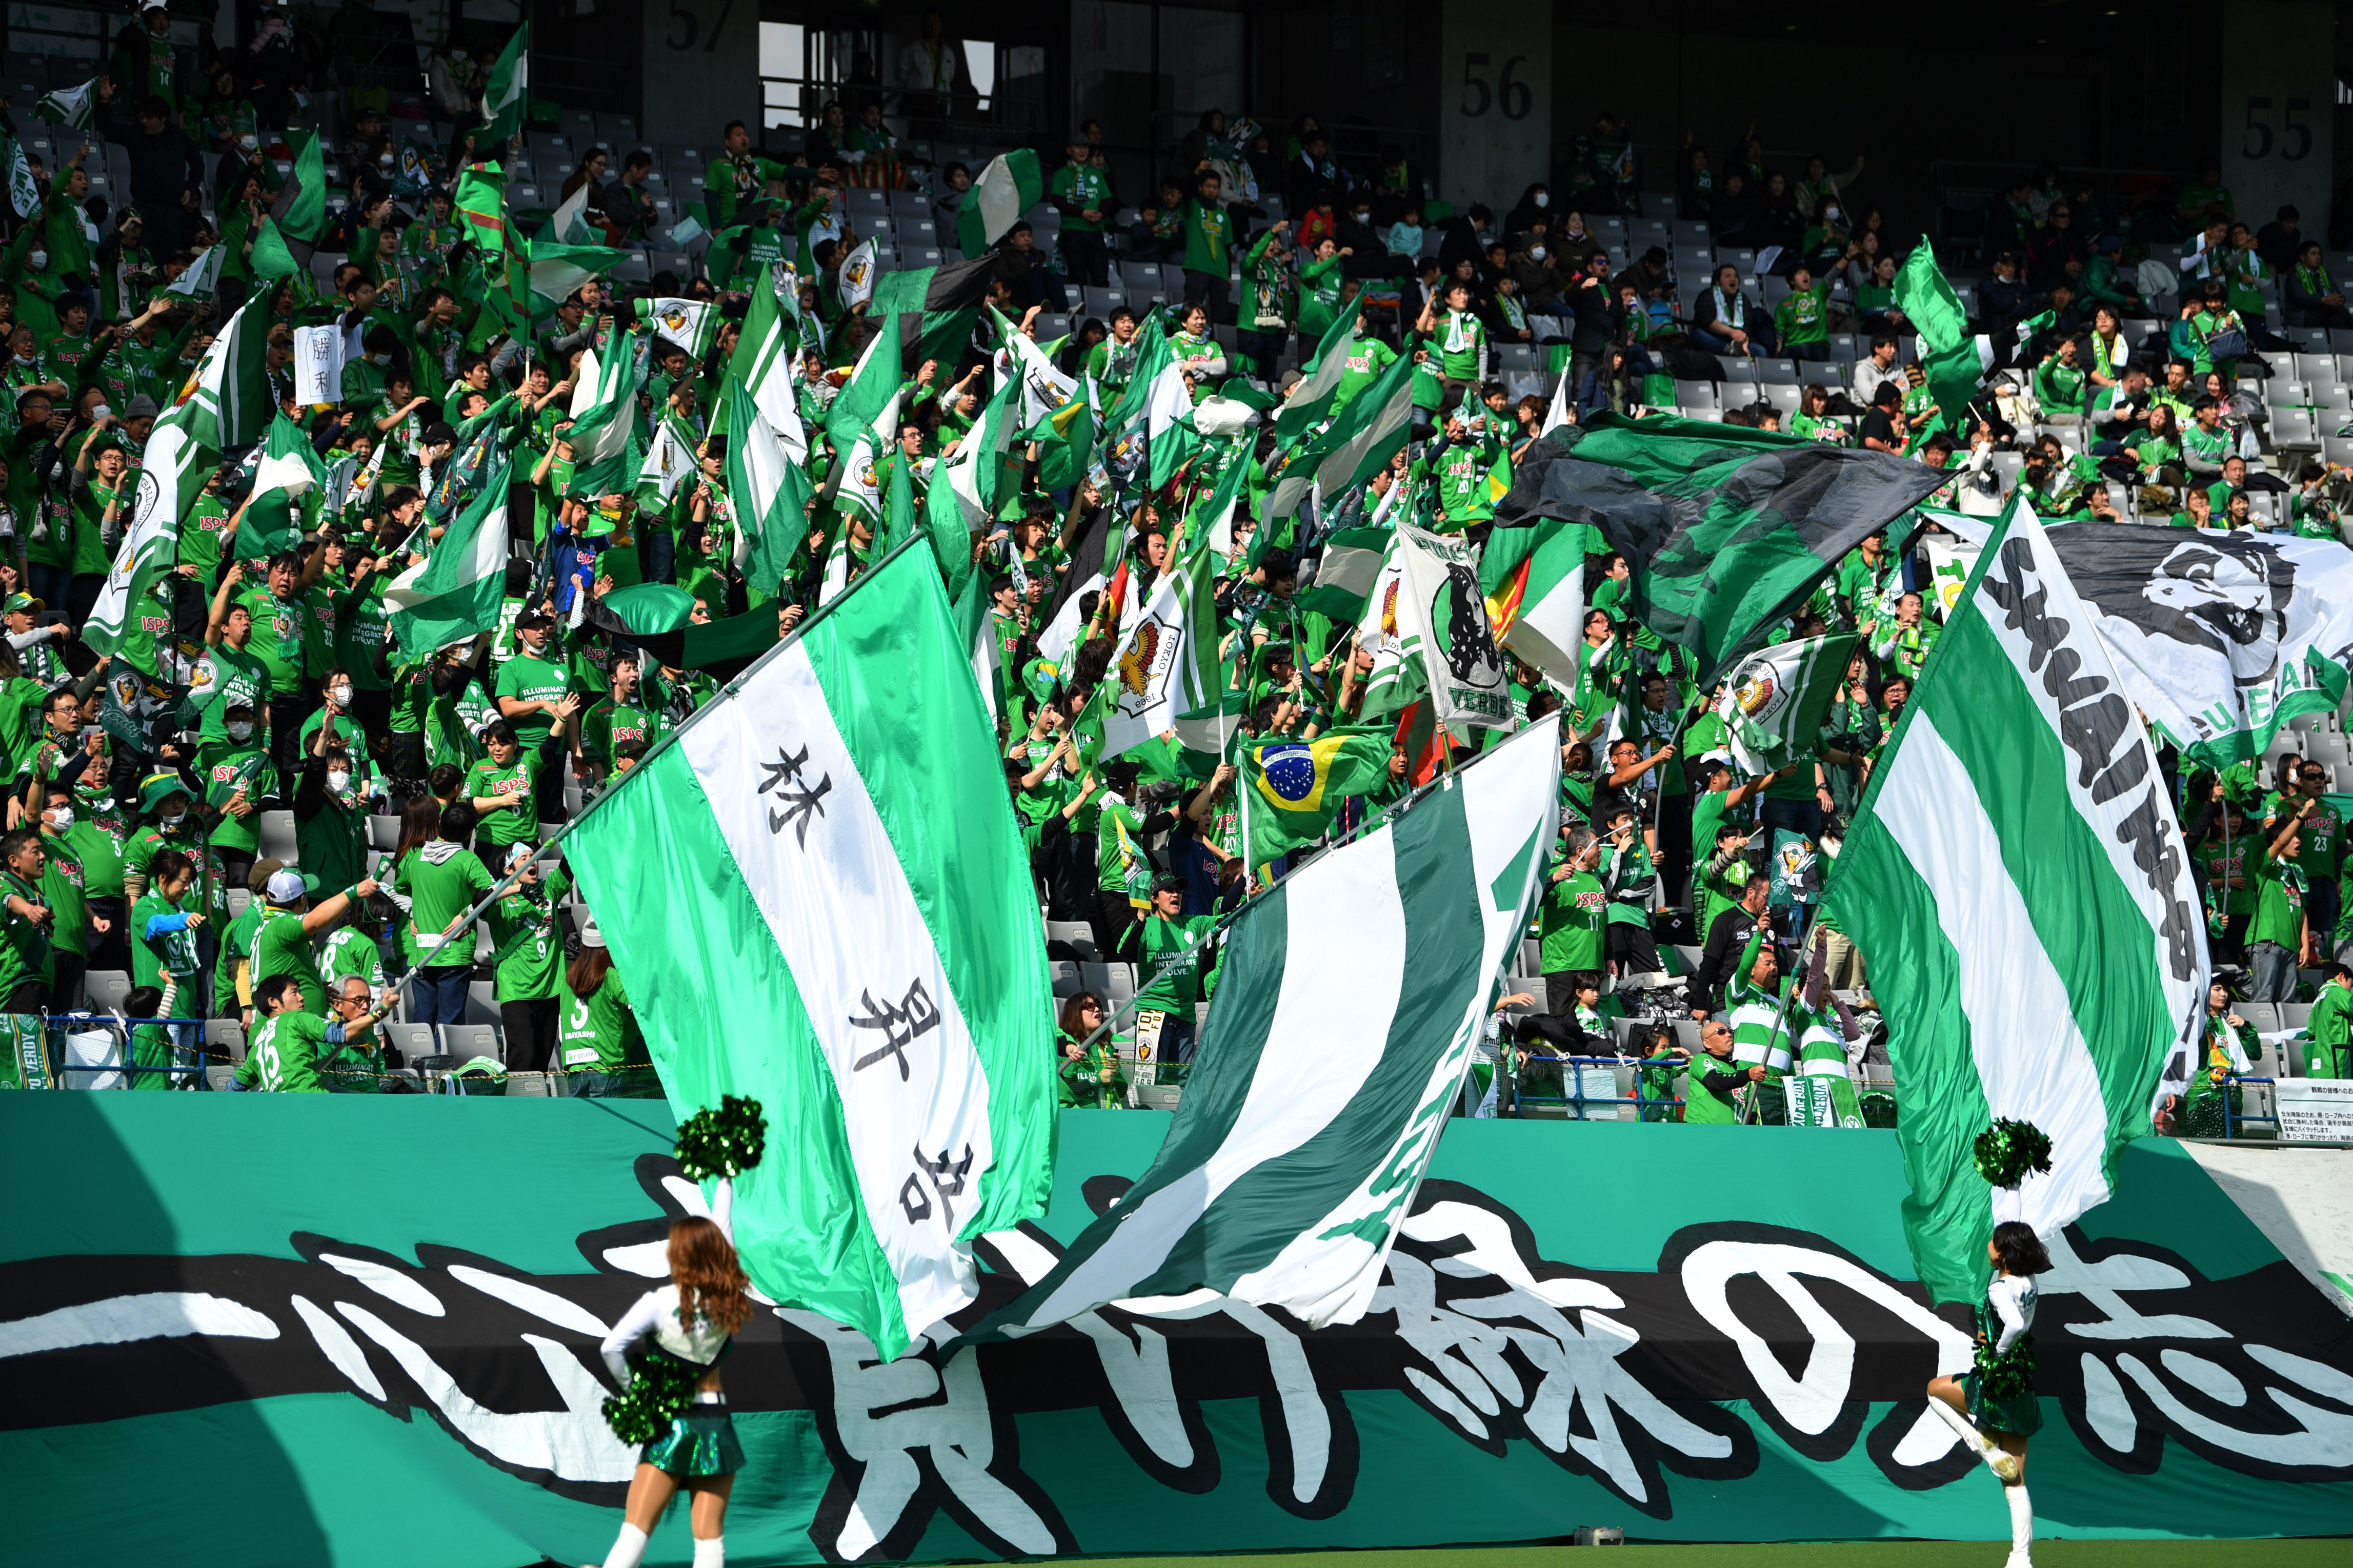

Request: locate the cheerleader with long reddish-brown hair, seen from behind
(586, 1215), (751, 1568)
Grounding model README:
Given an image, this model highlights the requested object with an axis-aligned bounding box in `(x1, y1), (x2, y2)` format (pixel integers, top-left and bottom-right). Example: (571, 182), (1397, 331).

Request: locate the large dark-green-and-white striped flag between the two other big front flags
(964, 722), (1560, 1338)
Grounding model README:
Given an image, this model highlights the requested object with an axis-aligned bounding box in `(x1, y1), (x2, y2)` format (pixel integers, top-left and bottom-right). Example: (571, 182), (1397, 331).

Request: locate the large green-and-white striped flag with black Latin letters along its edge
(1823, 503), (2207, 1302)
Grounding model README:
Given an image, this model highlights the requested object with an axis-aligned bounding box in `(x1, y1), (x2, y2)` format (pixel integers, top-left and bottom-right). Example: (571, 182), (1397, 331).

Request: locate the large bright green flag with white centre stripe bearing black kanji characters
(574, 548), (1056, 1359)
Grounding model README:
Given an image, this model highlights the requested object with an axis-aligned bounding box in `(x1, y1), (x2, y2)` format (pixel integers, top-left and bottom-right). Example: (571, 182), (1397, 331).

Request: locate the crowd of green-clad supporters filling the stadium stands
(0, 7), (2353, 1122)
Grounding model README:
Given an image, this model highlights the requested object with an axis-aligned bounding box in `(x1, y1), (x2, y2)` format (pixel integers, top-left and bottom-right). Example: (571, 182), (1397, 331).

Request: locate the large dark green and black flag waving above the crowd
(1496, 412), (1946, 686)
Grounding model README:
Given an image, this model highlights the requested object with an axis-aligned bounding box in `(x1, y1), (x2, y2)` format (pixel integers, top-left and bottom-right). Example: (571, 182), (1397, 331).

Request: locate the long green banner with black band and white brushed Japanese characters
(0, 1093), (2353, 1568)
